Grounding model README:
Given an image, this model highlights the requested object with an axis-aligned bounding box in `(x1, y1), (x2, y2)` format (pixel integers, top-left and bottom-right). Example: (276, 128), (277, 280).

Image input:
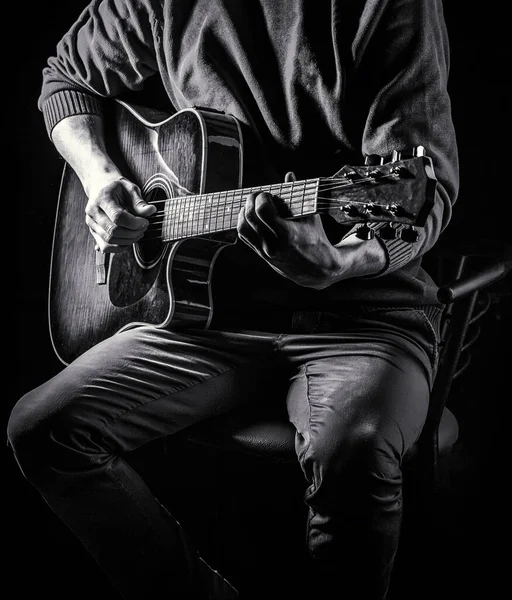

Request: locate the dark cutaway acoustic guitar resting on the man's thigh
(49, 100), (436, 364)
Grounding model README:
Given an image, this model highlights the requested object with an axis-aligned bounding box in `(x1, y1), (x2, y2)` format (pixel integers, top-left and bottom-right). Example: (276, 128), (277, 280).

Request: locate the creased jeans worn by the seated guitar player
(8, 309), (436, 600)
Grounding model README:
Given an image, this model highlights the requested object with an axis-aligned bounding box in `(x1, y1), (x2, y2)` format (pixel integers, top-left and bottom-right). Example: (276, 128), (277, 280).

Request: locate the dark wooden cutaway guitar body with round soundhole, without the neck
(49, 102), (243, 364)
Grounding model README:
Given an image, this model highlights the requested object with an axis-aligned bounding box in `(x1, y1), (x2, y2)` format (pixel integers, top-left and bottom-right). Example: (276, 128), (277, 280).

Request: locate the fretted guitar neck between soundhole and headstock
(160, 178), (320, 242)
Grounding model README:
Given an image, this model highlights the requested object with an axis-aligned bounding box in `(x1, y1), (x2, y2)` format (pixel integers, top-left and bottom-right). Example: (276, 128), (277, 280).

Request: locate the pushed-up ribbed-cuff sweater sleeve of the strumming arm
(38, 0), (159, 135)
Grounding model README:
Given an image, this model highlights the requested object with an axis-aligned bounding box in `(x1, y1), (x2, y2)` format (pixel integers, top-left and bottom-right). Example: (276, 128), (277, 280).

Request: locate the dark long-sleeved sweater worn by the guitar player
(39, 0), (458, 310)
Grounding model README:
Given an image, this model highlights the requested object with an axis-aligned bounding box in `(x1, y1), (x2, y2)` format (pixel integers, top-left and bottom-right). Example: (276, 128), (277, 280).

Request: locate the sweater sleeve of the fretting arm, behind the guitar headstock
(347, 0), (459, 277)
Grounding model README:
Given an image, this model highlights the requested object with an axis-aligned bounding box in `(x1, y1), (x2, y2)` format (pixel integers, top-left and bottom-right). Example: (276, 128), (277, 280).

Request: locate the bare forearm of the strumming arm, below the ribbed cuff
(52, 115), (121, 195)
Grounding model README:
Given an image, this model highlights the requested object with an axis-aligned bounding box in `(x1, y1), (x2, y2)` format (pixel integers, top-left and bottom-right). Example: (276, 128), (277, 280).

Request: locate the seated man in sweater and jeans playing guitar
(8, 0), (458, 600)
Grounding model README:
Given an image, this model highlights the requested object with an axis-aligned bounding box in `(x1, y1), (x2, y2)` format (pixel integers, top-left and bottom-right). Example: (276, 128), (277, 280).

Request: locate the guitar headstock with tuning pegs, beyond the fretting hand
(319, 146), (437, 241)
